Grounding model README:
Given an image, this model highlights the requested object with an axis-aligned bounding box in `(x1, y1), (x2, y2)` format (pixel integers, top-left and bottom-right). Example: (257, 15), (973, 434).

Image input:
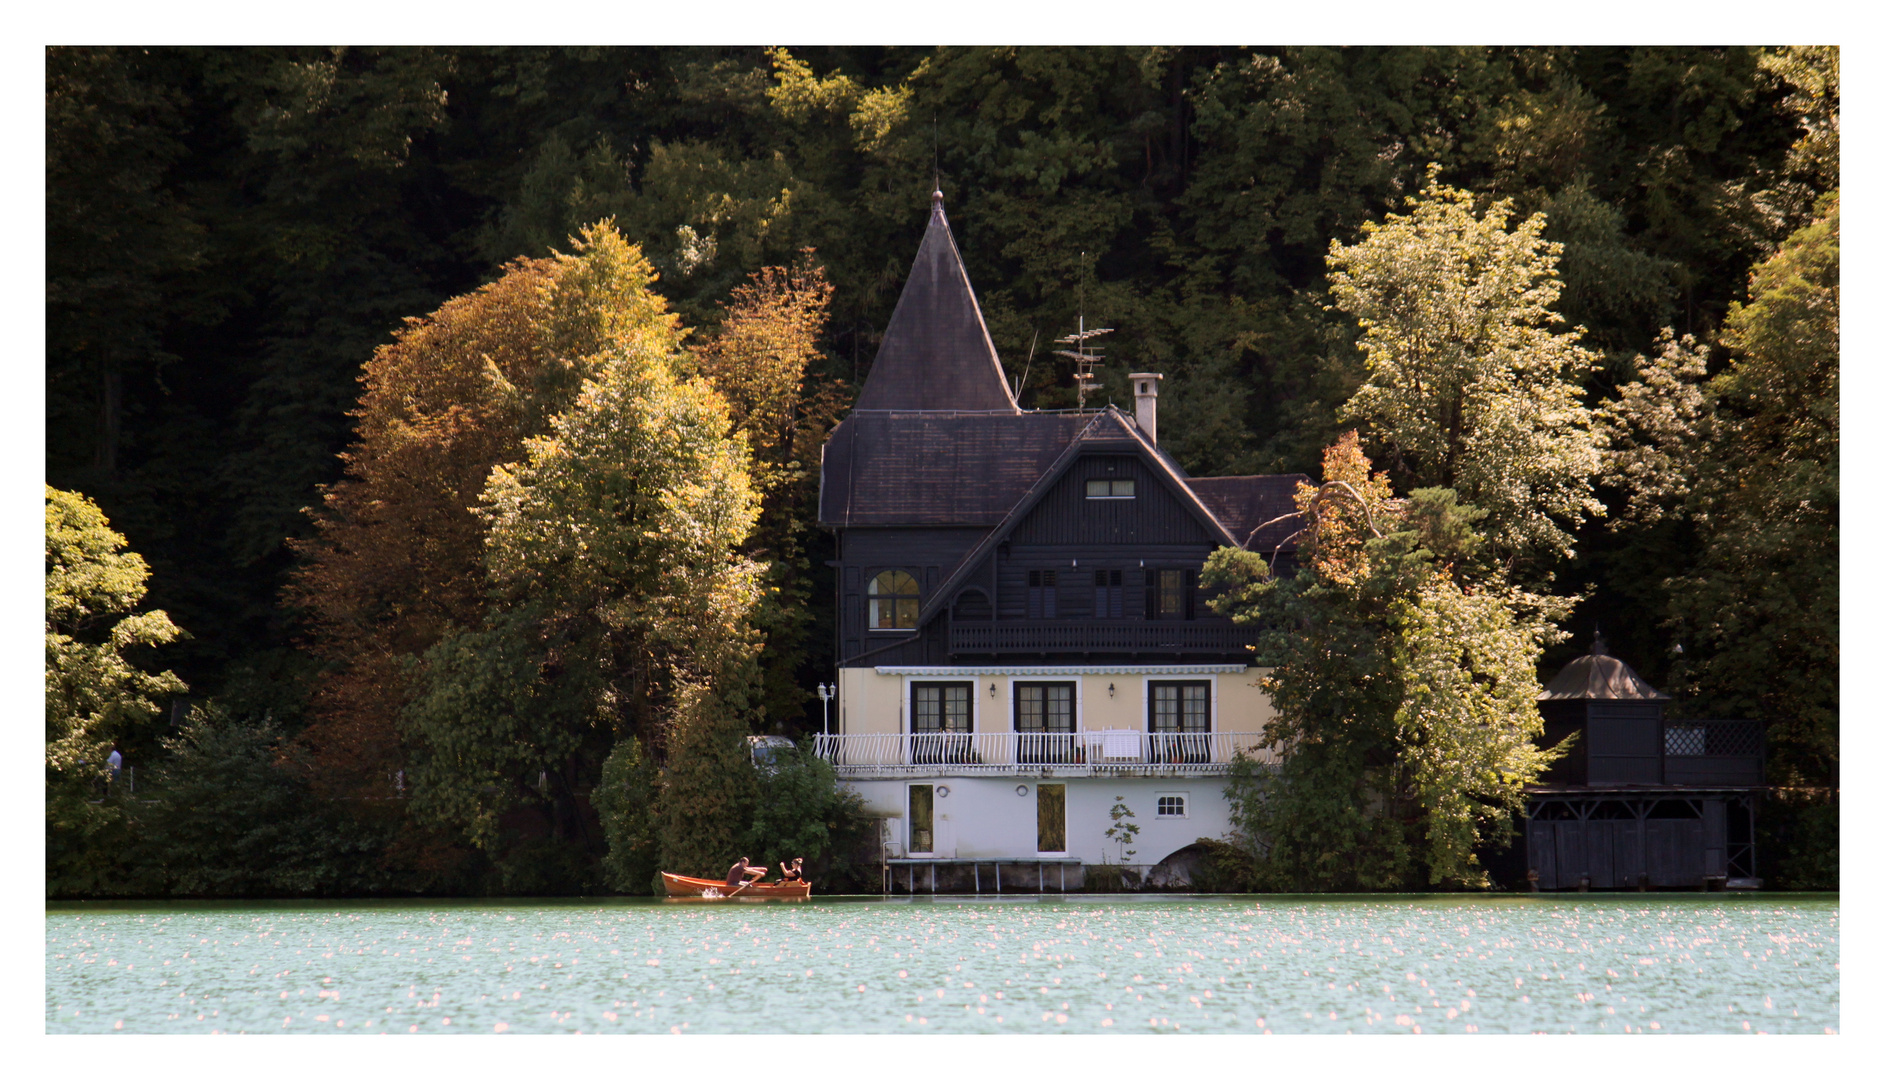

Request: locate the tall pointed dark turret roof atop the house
(856, 192), (1020, 413)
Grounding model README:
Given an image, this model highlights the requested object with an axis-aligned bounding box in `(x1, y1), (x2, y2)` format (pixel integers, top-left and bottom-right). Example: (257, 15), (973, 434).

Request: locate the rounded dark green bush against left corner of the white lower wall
(742, 743), (877, 890)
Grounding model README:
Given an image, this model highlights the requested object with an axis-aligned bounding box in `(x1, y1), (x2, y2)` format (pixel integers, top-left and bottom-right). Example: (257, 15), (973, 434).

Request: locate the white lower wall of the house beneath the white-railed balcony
(844, 775), (1231, 867)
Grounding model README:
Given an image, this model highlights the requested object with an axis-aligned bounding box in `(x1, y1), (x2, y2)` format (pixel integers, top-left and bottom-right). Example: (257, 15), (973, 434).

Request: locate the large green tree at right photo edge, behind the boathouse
(1670, 192), (1840, 788)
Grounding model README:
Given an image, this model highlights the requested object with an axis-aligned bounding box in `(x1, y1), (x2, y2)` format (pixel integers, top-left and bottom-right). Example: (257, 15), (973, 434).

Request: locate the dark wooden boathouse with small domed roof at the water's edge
(1525, 635), (1764, 890)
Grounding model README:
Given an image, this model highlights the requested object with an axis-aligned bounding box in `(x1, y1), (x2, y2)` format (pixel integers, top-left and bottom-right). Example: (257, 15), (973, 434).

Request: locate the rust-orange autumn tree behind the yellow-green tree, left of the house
(288, 226), (680, 794)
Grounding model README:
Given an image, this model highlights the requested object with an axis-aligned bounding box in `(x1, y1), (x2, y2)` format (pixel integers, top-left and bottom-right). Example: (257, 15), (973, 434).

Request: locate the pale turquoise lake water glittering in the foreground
(45, 893), (1840, 1035)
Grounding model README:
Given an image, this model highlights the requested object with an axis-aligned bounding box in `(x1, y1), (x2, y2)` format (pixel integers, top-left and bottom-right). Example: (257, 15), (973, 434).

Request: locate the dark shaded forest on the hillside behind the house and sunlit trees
(45, 47), (1840, 897)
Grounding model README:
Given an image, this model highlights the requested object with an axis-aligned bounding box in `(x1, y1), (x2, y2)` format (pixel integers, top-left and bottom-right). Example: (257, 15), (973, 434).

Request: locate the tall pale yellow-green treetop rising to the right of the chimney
(1329, 172), (1602, 558)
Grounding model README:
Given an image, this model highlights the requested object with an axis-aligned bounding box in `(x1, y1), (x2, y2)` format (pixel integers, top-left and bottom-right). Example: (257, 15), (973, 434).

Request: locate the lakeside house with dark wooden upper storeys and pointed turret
(818, 192), (1306, 892)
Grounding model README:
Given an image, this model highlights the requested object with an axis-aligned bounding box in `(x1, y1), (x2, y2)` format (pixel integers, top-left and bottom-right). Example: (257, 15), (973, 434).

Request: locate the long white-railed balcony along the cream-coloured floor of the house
(816, 729), (1276, 778)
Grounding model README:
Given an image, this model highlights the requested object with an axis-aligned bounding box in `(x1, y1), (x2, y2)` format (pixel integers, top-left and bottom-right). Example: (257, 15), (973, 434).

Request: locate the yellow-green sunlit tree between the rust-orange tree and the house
(405, 318), (760, 854)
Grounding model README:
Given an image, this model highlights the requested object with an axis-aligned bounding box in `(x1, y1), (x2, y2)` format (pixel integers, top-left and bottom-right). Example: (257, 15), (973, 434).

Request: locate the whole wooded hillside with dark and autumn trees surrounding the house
(45, 47), (1840, 897)
